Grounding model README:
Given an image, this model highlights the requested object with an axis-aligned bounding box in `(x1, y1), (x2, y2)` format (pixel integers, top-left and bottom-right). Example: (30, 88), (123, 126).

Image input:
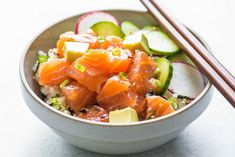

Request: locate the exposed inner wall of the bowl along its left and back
(20, 10), (209, 124)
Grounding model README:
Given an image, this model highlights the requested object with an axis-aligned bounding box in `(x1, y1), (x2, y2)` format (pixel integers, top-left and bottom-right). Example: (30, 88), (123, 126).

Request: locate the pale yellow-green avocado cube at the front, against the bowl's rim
(109, 107), (138, 124)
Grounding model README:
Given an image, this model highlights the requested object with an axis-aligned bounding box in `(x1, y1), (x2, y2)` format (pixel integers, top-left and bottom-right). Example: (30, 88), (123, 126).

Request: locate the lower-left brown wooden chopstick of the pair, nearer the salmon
(141, 0), (235, 107)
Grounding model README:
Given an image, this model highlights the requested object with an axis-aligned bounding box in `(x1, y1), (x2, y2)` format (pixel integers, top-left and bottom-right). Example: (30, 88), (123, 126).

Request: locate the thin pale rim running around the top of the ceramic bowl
(19, 9), (212, 127)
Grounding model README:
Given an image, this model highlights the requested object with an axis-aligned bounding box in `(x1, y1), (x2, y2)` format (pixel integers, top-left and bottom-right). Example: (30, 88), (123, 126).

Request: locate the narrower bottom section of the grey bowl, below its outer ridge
(52, 128), (184, 154)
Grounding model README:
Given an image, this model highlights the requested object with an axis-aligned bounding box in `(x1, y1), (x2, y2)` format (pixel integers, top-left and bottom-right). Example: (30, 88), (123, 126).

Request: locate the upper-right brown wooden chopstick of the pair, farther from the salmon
(151, 0), (235, 90)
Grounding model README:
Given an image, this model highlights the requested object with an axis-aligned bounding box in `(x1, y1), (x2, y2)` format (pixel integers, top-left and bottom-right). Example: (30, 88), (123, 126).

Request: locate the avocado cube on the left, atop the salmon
(63, 42), (89, 62)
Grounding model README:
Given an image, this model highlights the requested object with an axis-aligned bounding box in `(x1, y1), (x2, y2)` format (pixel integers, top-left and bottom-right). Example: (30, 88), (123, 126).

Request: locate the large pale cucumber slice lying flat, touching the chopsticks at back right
(145, 31), (179, 55)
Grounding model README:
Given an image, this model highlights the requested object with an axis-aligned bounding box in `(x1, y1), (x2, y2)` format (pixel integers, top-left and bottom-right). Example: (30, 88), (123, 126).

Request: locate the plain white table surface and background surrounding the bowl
(0, 0), (235, 157)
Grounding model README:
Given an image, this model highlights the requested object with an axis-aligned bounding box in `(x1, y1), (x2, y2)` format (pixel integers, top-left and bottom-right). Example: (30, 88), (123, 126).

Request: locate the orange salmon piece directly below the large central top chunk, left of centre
(68, 64), (109, 93)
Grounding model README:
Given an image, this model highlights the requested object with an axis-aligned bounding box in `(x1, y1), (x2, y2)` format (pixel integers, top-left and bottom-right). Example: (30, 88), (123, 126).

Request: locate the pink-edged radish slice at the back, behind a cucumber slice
(75, 11), (118, 34)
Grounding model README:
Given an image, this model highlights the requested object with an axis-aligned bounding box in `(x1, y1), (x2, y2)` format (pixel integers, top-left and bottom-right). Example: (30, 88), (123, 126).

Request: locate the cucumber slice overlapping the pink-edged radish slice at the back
(91, 21), (123, 38)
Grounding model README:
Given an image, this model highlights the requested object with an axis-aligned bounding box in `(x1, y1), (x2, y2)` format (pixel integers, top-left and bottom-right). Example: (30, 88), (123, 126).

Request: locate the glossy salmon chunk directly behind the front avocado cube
(97, 76), (147, 116)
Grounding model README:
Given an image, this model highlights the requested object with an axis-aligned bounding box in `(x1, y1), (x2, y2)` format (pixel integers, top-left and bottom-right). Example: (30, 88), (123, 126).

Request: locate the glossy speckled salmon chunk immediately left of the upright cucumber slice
(128, 51), (156, 95)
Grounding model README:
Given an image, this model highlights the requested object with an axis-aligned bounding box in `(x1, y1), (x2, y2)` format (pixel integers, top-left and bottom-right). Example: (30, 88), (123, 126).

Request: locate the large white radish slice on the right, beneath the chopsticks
(169, 62), (205, 99)
